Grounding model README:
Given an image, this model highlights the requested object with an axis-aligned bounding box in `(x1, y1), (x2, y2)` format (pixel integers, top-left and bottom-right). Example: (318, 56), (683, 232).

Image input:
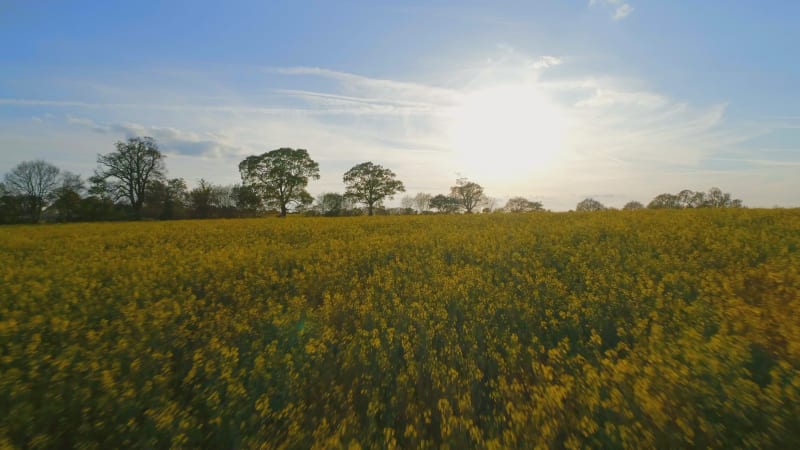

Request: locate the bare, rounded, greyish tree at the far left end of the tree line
(5, 159), (60, 223)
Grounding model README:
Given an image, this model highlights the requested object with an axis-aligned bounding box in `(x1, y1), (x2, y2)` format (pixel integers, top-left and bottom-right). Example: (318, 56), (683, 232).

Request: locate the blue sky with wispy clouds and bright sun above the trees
(0, 0), (800, 210)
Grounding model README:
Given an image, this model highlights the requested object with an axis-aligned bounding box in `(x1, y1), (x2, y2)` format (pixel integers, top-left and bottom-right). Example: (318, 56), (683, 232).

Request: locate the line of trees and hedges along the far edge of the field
(0, 137), (742, 223)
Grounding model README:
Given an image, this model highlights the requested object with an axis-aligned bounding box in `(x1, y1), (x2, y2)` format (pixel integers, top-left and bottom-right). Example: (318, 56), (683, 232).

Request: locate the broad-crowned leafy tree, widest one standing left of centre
(239, 147), (319, 217)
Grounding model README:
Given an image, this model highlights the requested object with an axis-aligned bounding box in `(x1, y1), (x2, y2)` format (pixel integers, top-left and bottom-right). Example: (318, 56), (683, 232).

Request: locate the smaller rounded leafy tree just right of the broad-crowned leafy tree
(343, 161), (406, 216)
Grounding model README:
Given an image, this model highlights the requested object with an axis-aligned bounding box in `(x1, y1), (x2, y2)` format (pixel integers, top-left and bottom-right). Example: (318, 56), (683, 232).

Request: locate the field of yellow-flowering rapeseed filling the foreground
(0, 210), (800, 449)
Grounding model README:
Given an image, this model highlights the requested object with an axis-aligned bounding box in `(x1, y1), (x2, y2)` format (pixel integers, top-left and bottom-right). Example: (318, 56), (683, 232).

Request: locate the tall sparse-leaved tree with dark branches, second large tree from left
(92, 137), (166, 215)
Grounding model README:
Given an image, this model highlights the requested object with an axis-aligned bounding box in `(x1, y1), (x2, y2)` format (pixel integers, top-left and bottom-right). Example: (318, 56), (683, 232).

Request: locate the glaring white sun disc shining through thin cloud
(447, 84), (568, 179)
